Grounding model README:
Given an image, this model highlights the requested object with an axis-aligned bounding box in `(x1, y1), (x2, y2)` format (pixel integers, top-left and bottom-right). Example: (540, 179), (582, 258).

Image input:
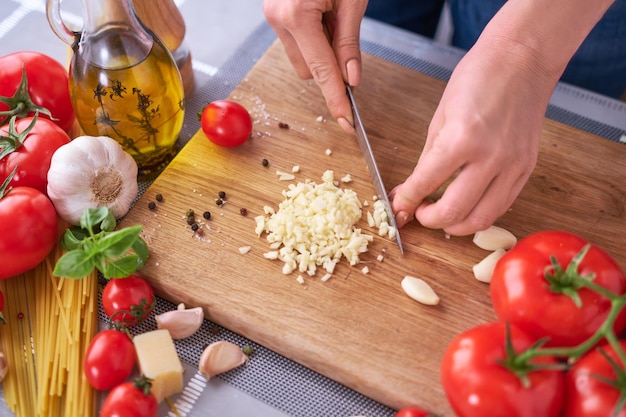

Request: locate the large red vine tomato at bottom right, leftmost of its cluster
(441, 322), (564, 417)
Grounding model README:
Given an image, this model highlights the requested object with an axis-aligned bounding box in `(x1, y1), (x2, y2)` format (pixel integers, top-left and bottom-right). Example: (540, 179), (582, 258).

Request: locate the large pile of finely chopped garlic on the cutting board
(255, 170), (373, 276)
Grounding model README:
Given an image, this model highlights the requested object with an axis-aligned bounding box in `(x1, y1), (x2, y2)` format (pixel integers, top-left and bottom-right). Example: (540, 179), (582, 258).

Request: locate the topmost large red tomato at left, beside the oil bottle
(0, 51), (76, 132)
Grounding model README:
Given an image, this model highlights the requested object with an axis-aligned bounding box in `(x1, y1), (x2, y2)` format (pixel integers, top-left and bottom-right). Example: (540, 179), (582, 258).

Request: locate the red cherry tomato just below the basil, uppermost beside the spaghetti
(102, 274), (156, 326)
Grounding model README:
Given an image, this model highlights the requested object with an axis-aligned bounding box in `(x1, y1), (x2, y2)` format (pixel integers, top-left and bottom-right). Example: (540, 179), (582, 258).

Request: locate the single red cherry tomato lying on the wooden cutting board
(200, 100), (252, 148)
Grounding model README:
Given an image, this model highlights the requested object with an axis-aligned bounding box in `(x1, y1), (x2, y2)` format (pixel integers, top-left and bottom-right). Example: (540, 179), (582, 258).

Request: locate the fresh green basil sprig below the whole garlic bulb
(53, 207), (148, 279)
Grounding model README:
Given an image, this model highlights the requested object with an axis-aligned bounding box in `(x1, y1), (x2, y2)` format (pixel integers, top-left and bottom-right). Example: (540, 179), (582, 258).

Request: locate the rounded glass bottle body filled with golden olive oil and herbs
(70, 25), (184, 175)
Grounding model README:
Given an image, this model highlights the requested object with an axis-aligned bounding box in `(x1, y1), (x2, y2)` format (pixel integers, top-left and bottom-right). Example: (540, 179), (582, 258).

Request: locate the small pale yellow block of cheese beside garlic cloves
(133, 329), (183, 402)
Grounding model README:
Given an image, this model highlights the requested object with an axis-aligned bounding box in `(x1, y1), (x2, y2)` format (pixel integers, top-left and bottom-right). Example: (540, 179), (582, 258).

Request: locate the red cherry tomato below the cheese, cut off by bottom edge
(100, 379), (158, 417)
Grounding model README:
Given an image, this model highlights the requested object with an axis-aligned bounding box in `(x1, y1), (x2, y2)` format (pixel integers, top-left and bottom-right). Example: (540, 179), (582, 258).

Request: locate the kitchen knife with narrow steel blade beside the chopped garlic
(322, 12), (404, 254)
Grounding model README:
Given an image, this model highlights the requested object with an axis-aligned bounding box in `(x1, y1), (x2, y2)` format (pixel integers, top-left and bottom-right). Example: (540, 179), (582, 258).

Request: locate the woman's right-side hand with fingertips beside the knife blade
(391, 42), (554, 235)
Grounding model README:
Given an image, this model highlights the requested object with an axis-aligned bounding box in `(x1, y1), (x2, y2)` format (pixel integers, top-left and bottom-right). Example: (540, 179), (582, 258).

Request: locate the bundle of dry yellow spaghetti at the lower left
(0, 246), (98, 417)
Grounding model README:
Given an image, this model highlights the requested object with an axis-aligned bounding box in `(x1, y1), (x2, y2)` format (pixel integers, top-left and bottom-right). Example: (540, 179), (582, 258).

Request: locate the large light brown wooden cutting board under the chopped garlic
(122, 38), (626, 416)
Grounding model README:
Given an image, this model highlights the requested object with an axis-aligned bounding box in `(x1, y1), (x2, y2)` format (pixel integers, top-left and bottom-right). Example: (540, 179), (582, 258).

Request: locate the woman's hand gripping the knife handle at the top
(263, 0), (367, 132)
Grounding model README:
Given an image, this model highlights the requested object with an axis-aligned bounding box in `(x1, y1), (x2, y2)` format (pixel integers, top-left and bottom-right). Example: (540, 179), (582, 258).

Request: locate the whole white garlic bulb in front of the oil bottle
(48, 136), (138, 225)
